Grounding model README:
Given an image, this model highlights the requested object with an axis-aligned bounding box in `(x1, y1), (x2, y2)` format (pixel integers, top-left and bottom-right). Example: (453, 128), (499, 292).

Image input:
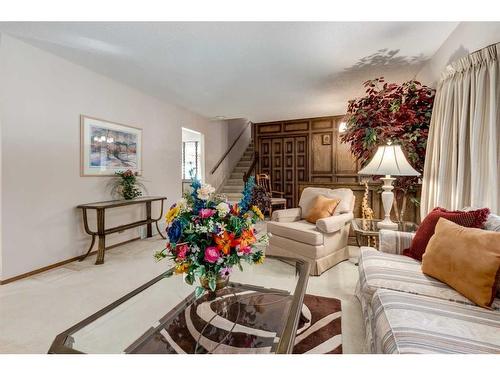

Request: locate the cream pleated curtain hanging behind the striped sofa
(420, 43), (500, 218)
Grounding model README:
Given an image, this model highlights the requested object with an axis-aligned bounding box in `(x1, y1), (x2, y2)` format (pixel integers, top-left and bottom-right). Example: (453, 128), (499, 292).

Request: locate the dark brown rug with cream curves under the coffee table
(129, 287), (342, 354)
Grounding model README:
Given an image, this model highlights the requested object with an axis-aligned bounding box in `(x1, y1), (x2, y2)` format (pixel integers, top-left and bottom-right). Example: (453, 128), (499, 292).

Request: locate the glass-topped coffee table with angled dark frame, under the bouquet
(49, 256), (310, 354)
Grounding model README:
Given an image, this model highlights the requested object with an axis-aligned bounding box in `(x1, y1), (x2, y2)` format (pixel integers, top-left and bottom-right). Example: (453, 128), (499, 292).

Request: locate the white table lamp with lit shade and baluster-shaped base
(358, 143), (420, 230)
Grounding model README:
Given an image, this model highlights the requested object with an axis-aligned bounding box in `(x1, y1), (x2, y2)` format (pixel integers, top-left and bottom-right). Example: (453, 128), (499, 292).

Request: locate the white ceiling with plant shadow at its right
(0, 22), (457, 122)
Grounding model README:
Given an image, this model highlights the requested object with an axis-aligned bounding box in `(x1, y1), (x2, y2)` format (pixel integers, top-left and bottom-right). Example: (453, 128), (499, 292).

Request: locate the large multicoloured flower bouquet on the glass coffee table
(155, 178), (268, 297)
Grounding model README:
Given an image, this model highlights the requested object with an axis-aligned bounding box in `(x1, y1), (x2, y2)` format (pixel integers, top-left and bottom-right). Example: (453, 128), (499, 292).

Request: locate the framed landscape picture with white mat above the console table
(80, 115), (142, 176)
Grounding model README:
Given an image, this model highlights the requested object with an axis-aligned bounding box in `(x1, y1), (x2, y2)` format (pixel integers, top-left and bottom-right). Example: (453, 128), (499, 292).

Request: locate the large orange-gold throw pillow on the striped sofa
(422, 218), (500, 307)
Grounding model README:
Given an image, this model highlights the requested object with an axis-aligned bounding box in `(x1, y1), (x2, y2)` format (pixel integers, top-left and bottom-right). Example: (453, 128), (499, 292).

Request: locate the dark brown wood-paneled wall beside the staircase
(253, 116), (359, 207)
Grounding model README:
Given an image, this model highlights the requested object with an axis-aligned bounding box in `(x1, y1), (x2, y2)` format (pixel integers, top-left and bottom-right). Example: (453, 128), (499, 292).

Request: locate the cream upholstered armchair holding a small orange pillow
(266, 187), (355, 276)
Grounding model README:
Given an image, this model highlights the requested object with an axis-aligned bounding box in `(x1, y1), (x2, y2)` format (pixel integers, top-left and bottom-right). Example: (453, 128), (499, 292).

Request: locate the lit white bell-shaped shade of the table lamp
(358, 145), (420, 176)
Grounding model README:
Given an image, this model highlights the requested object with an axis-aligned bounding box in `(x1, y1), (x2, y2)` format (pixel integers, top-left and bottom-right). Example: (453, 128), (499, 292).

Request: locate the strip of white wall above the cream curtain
(416, 22), (500, 87)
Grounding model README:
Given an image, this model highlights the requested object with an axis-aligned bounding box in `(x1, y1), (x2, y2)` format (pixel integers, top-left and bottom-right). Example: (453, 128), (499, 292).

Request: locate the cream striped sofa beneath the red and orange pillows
(356, 230), (500, 354)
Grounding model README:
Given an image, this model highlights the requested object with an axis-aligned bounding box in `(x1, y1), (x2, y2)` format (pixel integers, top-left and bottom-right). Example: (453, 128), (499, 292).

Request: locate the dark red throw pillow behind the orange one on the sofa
(403, 207), (490, 261)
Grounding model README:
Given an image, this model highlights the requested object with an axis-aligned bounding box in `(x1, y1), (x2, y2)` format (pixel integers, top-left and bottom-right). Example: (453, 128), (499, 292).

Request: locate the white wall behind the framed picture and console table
(0, 35), (228, 280)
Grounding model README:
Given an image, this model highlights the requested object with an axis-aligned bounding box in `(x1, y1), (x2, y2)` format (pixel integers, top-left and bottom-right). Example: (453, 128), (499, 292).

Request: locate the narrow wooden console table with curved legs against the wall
(77, 196), (167, 264)
